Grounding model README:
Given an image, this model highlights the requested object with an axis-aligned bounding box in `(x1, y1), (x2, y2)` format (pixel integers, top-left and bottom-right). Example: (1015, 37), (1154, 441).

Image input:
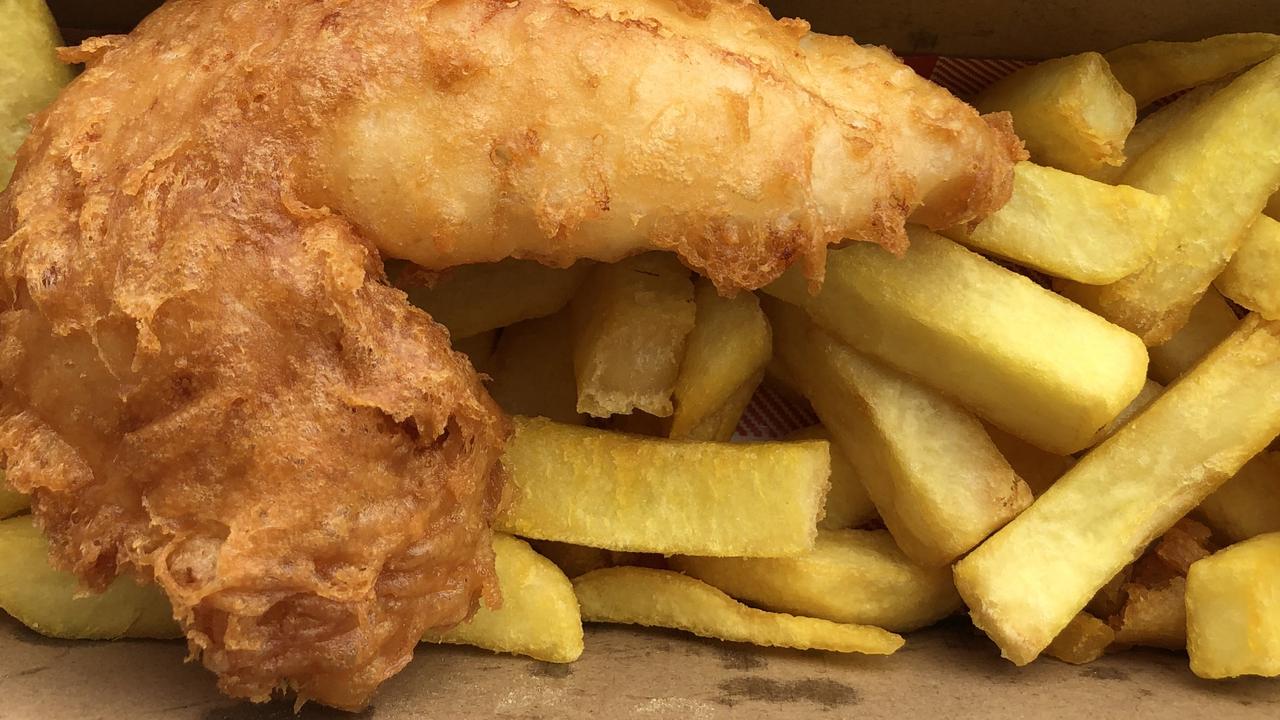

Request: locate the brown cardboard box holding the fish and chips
(0, 0), (1280, 720)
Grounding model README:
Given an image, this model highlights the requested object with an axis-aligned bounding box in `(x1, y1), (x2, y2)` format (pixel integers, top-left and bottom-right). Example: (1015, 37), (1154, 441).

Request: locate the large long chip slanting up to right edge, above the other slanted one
(1060, 56), (1280, 346)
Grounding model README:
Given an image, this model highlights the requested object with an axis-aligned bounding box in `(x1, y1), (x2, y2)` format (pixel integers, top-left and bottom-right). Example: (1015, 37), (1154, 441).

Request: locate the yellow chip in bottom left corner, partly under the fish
(0, 516), (182, 641)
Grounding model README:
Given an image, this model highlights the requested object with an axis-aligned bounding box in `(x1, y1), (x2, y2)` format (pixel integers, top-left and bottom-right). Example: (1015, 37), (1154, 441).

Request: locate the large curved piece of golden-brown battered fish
(0, 0), (1021, 708)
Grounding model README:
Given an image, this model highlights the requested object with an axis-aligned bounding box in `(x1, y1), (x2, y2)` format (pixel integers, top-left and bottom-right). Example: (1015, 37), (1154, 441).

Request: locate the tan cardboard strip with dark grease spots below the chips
(0, 609), (1280, 720)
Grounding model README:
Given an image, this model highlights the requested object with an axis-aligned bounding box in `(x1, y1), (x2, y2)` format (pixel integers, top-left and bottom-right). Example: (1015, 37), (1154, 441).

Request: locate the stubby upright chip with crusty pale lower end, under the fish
(571, 252), (696, 418)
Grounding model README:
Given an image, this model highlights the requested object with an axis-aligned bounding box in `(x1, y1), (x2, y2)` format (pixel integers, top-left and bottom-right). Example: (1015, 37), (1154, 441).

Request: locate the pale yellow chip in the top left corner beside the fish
(0, 0), (74, 190)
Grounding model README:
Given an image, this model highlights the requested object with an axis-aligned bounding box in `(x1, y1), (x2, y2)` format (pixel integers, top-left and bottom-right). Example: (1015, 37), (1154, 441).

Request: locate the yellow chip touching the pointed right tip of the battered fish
(943, 163), (1169, 284)
